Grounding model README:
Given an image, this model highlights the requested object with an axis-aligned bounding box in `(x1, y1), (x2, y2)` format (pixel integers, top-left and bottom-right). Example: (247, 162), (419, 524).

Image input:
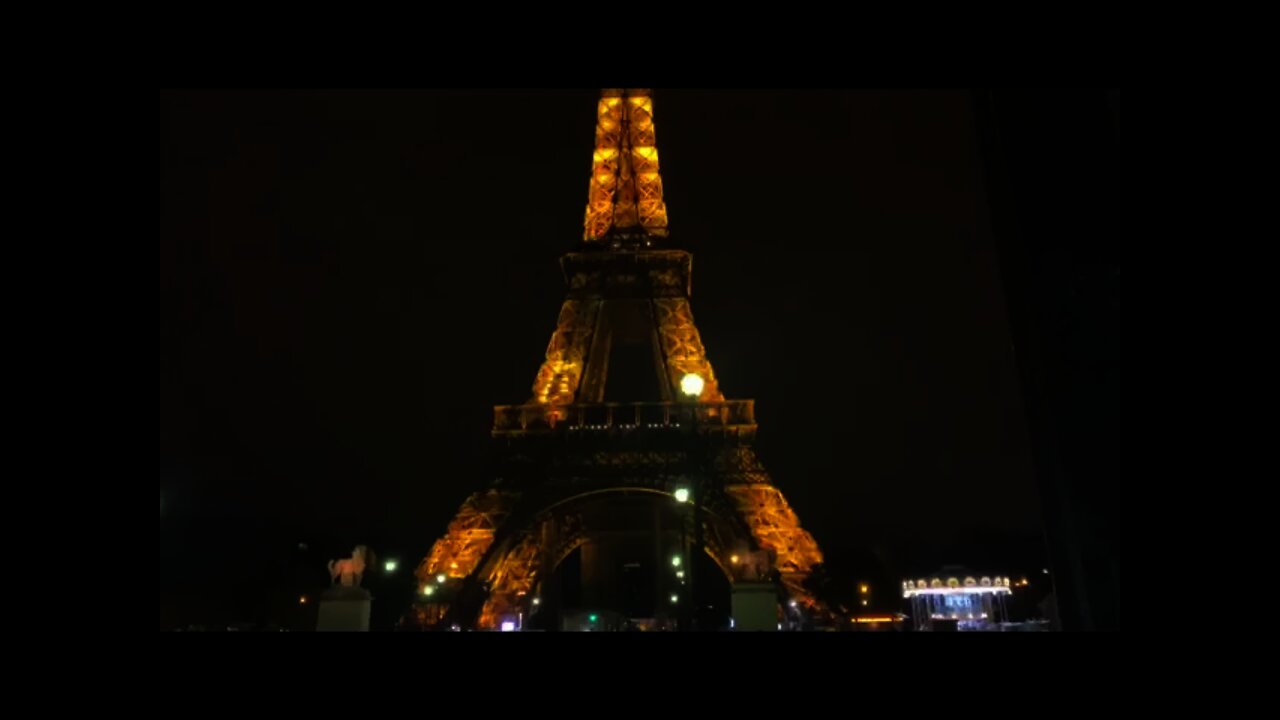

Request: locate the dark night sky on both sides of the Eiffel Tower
(160, 90), (1039, 584)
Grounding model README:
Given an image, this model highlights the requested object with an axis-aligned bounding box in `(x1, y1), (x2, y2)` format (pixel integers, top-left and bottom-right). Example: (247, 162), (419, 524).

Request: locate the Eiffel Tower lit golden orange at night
(415, 90), (822, 629)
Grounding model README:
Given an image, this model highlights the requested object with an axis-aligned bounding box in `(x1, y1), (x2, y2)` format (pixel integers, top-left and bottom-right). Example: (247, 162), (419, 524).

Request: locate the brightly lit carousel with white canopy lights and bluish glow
(902, 571), (1012, 630)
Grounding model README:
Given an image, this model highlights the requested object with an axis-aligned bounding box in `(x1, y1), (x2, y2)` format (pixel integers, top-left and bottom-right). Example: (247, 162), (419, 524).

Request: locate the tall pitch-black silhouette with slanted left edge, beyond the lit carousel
(975, 91), (1134, 630)
